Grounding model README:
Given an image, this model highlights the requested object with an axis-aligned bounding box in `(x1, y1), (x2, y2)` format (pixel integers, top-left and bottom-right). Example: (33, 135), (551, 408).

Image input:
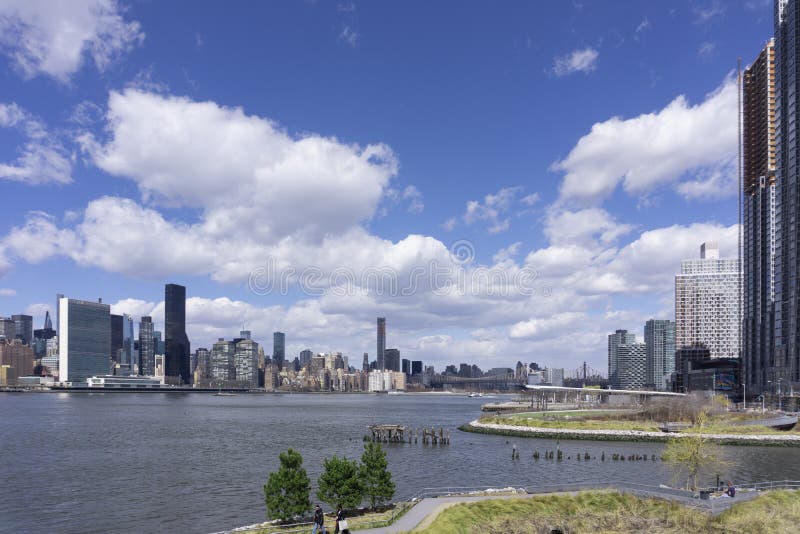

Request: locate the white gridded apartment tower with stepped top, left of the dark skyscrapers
(675, 242), (742, 358)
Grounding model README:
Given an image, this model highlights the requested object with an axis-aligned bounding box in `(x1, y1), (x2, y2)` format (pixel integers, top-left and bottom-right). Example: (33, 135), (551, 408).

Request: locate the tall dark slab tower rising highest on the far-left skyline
(164, 284), (192, 385)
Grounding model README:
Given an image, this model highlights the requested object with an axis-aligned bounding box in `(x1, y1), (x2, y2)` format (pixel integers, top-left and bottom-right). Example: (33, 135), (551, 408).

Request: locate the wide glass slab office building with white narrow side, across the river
(58, 297), (111, 386)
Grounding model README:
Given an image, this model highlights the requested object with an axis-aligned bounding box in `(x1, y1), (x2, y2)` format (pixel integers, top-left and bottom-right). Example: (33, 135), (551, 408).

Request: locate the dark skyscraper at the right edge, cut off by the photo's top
(776, 0), (800, 388)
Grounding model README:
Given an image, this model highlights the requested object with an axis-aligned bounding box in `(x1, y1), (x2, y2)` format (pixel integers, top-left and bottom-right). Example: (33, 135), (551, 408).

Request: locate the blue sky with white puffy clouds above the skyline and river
(0, 0), (772, 369)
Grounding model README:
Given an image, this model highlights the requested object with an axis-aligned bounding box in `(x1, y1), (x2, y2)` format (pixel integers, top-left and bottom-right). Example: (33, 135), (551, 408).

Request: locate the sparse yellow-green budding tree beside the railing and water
(663, 410), (726, 490)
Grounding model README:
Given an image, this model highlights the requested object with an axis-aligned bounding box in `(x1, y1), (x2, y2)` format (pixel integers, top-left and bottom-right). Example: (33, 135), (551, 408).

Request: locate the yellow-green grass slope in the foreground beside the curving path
(421, 491), (800, 534)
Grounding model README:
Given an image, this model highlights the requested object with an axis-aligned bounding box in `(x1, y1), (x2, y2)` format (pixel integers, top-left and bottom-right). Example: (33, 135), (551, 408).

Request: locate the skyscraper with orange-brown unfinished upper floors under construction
(741, 39), (777, 393)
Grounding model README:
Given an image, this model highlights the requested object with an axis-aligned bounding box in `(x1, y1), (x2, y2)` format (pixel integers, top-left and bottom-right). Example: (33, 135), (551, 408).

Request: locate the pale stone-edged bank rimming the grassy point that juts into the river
(458, 419), (800, 447)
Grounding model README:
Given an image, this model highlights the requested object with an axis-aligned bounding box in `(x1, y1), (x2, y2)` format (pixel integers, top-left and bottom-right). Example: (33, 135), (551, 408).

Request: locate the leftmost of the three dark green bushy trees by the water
(264, 449), (311, 521)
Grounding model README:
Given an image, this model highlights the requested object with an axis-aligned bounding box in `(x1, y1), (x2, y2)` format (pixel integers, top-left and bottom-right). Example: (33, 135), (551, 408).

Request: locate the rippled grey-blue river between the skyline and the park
(0, 393), (800, 533)
